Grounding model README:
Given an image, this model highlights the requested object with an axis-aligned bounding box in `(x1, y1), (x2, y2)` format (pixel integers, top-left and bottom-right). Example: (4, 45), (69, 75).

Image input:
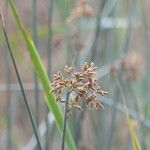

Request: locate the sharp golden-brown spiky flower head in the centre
(52, 63), (108, 113)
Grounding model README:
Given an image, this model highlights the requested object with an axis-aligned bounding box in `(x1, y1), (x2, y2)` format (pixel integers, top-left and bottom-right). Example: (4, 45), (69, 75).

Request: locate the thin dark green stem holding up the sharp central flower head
(61, 91), (70, 150)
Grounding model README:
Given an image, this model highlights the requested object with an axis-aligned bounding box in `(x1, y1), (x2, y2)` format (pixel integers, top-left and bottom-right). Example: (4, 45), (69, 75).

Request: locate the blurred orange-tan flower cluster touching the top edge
(67, 0), (93, 23)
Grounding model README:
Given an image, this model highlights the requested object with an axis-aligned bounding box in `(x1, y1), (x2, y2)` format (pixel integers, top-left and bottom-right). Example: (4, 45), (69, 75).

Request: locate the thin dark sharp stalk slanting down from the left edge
(0, 14), (42, 150)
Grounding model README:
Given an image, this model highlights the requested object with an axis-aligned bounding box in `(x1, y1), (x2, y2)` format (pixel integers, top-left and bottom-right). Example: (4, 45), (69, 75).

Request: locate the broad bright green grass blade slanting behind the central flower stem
(8, 0), (76, 150)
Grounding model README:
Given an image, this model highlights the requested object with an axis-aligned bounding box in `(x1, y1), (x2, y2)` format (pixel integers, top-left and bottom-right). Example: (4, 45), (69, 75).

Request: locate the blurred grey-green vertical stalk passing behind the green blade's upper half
(32, 0), (39, 127)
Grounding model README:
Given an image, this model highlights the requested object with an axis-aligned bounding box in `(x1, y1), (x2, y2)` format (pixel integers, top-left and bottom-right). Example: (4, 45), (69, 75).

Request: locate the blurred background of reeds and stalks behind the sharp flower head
(0, 0), (150, 150)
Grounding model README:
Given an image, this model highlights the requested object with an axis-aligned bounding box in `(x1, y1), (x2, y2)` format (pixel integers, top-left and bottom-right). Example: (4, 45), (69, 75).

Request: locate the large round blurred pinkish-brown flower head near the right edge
(122, 53), (144, 80)
